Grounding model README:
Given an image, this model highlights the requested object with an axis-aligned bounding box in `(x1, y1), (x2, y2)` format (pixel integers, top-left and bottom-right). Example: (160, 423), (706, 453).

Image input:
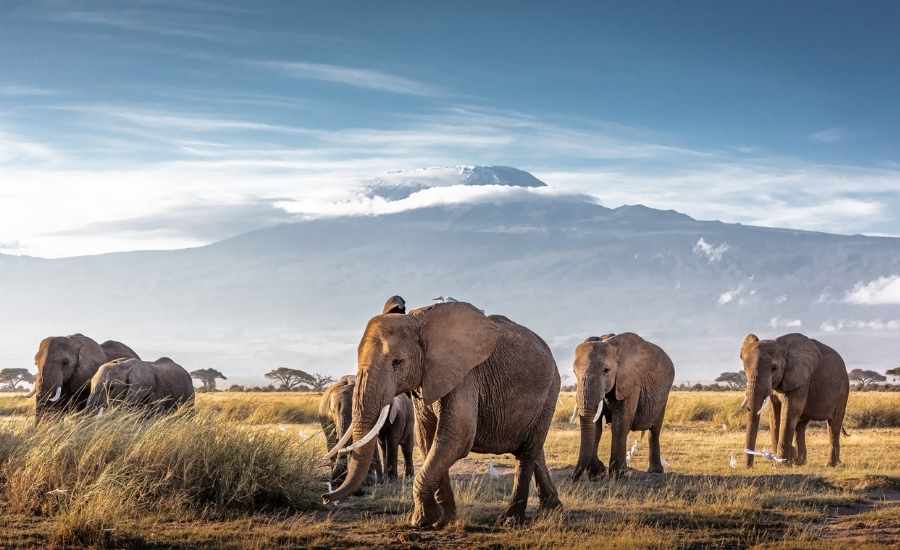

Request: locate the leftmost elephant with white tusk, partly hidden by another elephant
(33, 334), (138, 420)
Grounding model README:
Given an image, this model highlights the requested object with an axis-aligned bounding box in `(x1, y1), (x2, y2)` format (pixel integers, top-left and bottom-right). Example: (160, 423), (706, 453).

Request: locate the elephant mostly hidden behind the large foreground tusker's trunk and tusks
(319, 374), (381, 490)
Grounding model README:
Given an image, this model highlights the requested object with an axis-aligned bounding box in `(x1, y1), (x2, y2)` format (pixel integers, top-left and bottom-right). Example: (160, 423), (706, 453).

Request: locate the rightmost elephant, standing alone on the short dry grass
(741, 333), (850, 468)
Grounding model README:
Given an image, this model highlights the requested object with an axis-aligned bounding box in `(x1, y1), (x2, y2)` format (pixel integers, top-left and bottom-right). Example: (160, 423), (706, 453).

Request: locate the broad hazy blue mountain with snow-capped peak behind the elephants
(0, 167), (900, 383)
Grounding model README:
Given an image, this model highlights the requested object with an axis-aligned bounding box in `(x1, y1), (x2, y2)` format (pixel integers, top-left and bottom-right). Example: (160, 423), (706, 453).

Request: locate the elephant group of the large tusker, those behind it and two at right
(319, 296), (849, 528)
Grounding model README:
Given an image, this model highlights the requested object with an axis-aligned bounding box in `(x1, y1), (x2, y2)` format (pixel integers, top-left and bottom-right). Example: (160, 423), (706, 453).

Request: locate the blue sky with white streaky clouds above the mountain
(0, 0), (900, 257)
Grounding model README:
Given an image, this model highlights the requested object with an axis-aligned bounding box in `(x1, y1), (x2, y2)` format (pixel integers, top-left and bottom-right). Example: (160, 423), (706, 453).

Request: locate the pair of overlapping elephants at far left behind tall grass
(33, 334), (194, 420)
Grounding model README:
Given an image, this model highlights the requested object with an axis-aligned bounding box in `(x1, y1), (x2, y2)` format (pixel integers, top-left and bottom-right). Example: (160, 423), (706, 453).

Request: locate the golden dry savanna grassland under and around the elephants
(0, 392), (900, 548)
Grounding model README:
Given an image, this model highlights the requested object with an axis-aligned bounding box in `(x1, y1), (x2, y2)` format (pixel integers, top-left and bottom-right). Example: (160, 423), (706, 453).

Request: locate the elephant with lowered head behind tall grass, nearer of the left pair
(87, 357), (194, 413)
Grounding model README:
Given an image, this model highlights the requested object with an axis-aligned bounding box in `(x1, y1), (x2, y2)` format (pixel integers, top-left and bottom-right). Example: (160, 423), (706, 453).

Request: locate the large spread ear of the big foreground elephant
(417, 302), (500, 405)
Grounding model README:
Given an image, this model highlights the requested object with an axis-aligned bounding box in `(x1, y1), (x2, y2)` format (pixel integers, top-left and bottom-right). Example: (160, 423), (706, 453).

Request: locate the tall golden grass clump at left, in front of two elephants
(0, 410), (320, 544)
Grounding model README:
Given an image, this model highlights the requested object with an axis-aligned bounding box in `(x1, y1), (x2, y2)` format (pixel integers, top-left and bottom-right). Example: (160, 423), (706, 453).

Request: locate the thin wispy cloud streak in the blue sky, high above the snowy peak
(250, 61), (447, 97)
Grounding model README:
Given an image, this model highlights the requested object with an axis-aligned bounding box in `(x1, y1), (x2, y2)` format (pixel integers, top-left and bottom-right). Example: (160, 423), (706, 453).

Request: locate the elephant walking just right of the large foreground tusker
(572, 332), (675, 481)
